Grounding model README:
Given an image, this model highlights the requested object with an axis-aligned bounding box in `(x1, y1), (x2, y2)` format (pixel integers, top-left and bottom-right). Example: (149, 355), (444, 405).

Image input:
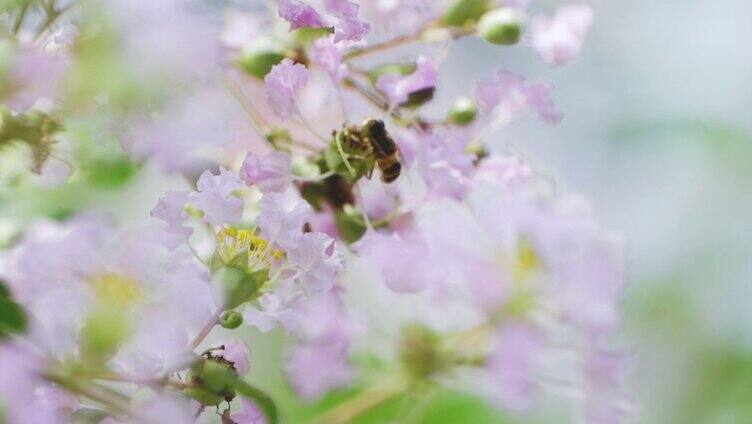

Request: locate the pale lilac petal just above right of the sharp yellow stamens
(258, 193), (312, 250)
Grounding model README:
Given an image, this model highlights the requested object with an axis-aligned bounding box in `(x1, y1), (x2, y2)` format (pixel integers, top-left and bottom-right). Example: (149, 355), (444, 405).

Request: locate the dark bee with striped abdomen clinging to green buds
(335, 119), (402, 184)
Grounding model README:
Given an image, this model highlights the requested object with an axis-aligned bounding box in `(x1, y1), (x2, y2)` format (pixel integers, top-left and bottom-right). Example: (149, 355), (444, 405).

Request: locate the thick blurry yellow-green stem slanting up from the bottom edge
(311, 377), (409, 424)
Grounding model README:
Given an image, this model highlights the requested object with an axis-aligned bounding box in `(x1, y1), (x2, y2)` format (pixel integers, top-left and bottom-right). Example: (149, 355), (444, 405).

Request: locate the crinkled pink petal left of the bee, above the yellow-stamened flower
(240, 152), (292, 193)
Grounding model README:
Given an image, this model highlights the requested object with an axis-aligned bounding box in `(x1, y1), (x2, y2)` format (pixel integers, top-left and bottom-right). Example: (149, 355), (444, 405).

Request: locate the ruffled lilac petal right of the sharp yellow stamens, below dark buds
(287, 233), (343, 291)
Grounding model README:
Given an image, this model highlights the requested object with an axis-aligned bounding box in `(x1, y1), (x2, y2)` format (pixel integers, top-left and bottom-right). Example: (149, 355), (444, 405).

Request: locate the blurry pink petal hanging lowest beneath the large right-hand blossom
(486, 324), (543, 409)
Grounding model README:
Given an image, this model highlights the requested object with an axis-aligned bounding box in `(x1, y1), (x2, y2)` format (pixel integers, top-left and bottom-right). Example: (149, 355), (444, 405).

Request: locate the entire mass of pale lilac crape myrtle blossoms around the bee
(0, 0), (630, 424)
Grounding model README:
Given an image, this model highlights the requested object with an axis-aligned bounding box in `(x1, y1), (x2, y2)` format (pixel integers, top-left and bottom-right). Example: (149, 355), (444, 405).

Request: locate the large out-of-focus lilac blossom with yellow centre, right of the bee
(357, 155), (623, 414)
